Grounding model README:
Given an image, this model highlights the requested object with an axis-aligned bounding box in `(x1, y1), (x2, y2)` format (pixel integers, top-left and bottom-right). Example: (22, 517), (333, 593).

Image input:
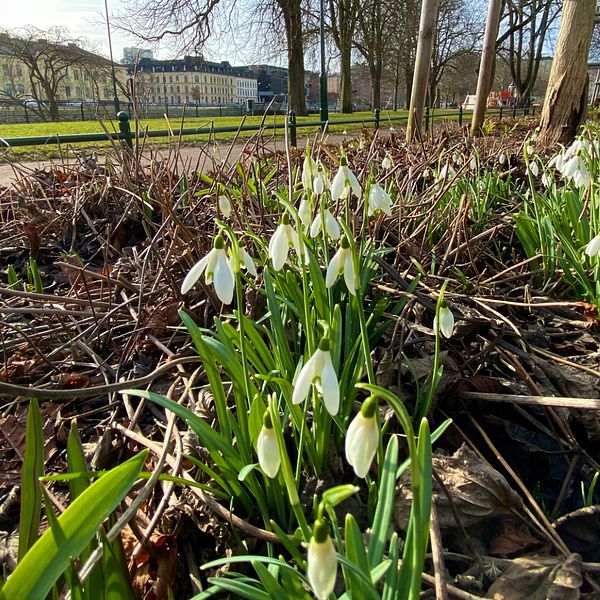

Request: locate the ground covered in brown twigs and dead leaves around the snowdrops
(0, 120), (600, 599)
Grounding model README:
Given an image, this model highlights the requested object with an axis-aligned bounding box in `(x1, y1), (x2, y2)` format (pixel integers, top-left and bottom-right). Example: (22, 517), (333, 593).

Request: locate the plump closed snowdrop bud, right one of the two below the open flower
(345, 396), (379, 478)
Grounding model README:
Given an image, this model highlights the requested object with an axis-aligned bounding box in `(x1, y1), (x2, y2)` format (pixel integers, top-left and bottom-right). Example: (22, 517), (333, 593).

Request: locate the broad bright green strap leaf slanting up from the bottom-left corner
(0, 451), (148, 600)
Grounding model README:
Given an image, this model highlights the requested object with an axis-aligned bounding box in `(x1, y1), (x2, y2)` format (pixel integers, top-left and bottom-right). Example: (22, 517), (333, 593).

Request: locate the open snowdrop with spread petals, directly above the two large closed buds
(292, 337), (340, 415)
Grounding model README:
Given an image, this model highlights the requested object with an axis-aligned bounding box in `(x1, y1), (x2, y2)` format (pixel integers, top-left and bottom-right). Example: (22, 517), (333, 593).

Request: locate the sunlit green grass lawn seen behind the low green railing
(0, 110), (458, 160)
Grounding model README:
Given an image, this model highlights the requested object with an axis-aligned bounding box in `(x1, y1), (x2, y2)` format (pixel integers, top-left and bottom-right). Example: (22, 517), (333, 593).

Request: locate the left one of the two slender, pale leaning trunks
(406, 0), (440, 142)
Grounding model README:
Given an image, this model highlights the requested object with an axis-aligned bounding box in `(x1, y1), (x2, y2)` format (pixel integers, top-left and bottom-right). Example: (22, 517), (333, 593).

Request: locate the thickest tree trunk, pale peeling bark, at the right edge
(538, 0), (596, 147)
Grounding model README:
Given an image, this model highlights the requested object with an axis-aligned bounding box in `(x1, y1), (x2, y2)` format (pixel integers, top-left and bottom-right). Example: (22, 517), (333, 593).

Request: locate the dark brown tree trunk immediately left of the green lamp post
(278, 0), (308, 117)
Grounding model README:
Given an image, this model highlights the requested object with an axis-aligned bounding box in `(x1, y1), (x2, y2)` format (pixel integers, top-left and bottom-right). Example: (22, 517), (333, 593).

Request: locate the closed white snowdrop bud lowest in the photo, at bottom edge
(306, 518), (337, 600)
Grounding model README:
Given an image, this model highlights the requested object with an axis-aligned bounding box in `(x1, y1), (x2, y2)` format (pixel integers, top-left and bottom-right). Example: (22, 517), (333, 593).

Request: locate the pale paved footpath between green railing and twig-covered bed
(0, 134), (349, 186)
